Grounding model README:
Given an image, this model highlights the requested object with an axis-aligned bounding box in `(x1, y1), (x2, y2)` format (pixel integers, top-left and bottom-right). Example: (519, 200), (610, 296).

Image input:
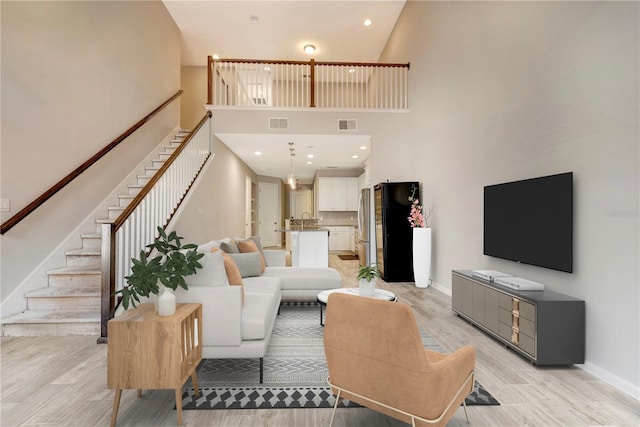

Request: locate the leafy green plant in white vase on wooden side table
(115, 227), (204, 316)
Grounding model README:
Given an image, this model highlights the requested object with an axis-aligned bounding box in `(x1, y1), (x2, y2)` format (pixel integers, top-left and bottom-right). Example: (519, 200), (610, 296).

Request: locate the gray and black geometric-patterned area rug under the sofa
(182, 302), (499, 409)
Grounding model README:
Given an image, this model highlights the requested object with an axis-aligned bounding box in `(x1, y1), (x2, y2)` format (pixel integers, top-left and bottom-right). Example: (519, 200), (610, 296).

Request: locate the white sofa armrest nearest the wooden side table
(175, 286), (242, 347)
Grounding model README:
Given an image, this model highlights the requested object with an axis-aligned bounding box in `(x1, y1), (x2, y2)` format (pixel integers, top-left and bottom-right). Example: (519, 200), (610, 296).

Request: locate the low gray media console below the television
(451, 270), (585, 365)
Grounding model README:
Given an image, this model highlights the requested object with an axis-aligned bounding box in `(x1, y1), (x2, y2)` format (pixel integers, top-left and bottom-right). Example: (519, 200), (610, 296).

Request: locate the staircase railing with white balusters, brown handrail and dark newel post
(99, 111), (212, 341)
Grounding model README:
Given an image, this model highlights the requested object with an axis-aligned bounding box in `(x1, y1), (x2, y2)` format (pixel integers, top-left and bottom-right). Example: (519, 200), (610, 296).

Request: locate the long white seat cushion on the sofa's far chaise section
(262, 267), (342, 290)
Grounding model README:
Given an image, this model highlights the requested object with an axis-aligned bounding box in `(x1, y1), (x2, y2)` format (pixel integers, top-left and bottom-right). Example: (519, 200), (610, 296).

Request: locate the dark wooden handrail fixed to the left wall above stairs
(0, 89), (183, 234)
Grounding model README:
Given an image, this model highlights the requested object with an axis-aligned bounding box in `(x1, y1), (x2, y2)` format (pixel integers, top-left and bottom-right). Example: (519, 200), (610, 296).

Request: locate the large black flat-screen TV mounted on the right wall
(484, 172), (573, 273)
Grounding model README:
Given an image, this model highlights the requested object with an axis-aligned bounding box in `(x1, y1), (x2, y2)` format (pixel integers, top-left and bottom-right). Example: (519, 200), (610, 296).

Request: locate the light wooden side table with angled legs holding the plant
(107, 304), (202, 427)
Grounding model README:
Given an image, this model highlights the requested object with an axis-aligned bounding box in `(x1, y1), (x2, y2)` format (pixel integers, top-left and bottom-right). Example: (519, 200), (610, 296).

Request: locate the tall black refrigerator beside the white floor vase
(374, 182), (419, 282)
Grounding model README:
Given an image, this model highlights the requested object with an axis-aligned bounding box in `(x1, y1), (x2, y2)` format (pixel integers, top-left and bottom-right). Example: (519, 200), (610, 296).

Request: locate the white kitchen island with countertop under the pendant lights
(278, 227), (329, 267)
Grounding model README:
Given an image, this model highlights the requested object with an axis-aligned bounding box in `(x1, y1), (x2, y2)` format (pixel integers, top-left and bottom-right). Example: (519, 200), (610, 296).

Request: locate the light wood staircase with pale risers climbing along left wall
(2, 130), (189, 337)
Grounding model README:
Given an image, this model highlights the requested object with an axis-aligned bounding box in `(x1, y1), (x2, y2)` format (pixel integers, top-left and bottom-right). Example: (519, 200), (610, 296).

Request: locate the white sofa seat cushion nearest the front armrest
(242, 292), (279, 341)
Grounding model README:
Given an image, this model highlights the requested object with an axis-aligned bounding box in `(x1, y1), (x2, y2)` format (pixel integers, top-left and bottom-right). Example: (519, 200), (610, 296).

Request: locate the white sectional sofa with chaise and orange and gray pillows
(170, 239), (342, 383)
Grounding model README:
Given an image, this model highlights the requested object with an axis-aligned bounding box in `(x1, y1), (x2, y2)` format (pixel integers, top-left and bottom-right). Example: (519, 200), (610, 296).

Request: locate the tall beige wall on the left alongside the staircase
(0, 1), (180, 301)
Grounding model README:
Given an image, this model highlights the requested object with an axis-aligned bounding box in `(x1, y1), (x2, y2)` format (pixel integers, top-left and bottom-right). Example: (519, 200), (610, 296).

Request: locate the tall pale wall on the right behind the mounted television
(378, 1), (640, 396)
